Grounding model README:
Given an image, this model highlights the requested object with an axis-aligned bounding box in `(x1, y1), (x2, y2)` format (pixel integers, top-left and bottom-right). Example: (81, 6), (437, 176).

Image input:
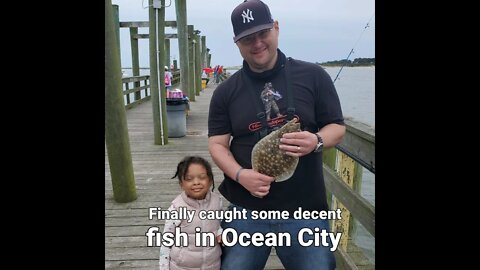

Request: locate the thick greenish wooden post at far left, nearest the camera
(105, 0), (137, 203)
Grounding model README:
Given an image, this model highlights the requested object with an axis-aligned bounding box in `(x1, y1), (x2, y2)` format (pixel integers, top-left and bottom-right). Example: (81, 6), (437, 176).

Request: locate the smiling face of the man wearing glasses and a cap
(236, 21), (279, 72)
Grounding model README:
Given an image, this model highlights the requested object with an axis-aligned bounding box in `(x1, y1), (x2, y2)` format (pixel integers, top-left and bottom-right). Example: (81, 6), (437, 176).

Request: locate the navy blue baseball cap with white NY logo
(232, 0), (273, 42)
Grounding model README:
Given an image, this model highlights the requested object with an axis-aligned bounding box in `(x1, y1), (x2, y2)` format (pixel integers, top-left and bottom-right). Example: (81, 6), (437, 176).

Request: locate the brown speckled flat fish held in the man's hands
(252, 118), (301, 182)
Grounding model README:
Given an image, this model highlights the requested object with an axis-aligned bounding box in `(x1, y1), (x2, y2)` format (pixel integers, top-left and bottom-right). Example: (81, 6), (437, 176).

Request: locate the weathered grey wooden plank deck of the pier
(105, 82), (284, 270)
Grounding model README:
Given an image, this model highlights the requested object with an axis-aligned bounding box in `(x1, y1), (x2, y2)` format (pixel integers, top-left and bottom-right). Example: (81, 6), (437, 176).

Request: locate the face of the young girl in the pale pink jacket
(180, 163), (212, 200)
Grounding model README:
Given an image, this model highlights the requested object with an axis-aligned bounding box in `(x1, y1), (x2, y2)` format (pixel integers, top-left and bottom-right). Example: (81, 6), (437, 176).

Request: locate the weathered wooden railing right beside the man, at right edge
(323, 119), (375, 269)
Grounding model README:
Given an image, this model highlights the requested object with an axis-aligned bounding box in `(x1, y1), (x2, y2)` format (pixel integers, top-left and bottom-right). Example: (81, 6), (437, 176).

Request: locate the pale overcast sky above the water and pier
(112, 0), (375, 67)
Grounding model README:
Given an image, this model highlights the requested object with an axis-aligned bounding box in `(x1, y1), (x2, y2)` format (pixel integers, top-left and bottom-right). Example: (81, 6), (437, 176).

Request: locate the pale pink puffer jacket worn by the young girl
(170, 191), (222, 270)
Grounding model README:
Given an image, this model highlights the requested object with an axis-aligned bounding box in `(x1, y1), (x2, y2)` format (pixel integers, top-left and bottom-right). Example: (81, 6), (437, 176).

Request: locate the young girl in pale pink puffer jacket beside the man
(159, 156), (222, 270)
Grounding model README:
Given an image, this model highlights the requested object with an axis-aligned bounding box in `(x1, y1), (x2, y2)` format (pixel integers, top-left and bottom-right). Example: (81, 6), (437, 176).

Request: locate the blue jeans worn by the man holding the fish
(221, 205), (336, 270)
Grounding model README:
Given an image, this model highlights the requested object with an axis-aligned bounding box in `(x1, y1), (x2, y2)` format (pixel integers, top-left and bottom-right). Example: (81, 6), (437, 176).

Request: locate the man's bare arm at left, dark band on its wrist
(208, 134), (275, 197)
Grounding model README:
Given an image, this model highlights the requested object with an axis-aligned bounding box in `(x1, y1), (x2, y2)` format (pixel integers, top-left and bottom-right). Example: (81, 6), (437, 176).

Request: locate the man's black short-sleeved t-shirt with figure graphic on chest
(208, 50), (343, 213)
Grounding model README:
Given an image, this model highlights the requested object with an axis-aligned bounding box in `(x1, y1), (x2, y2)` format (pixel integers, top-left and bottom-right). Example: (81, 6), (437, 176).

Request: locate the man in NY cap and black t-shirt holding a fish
(208, 0), (345, 270)
